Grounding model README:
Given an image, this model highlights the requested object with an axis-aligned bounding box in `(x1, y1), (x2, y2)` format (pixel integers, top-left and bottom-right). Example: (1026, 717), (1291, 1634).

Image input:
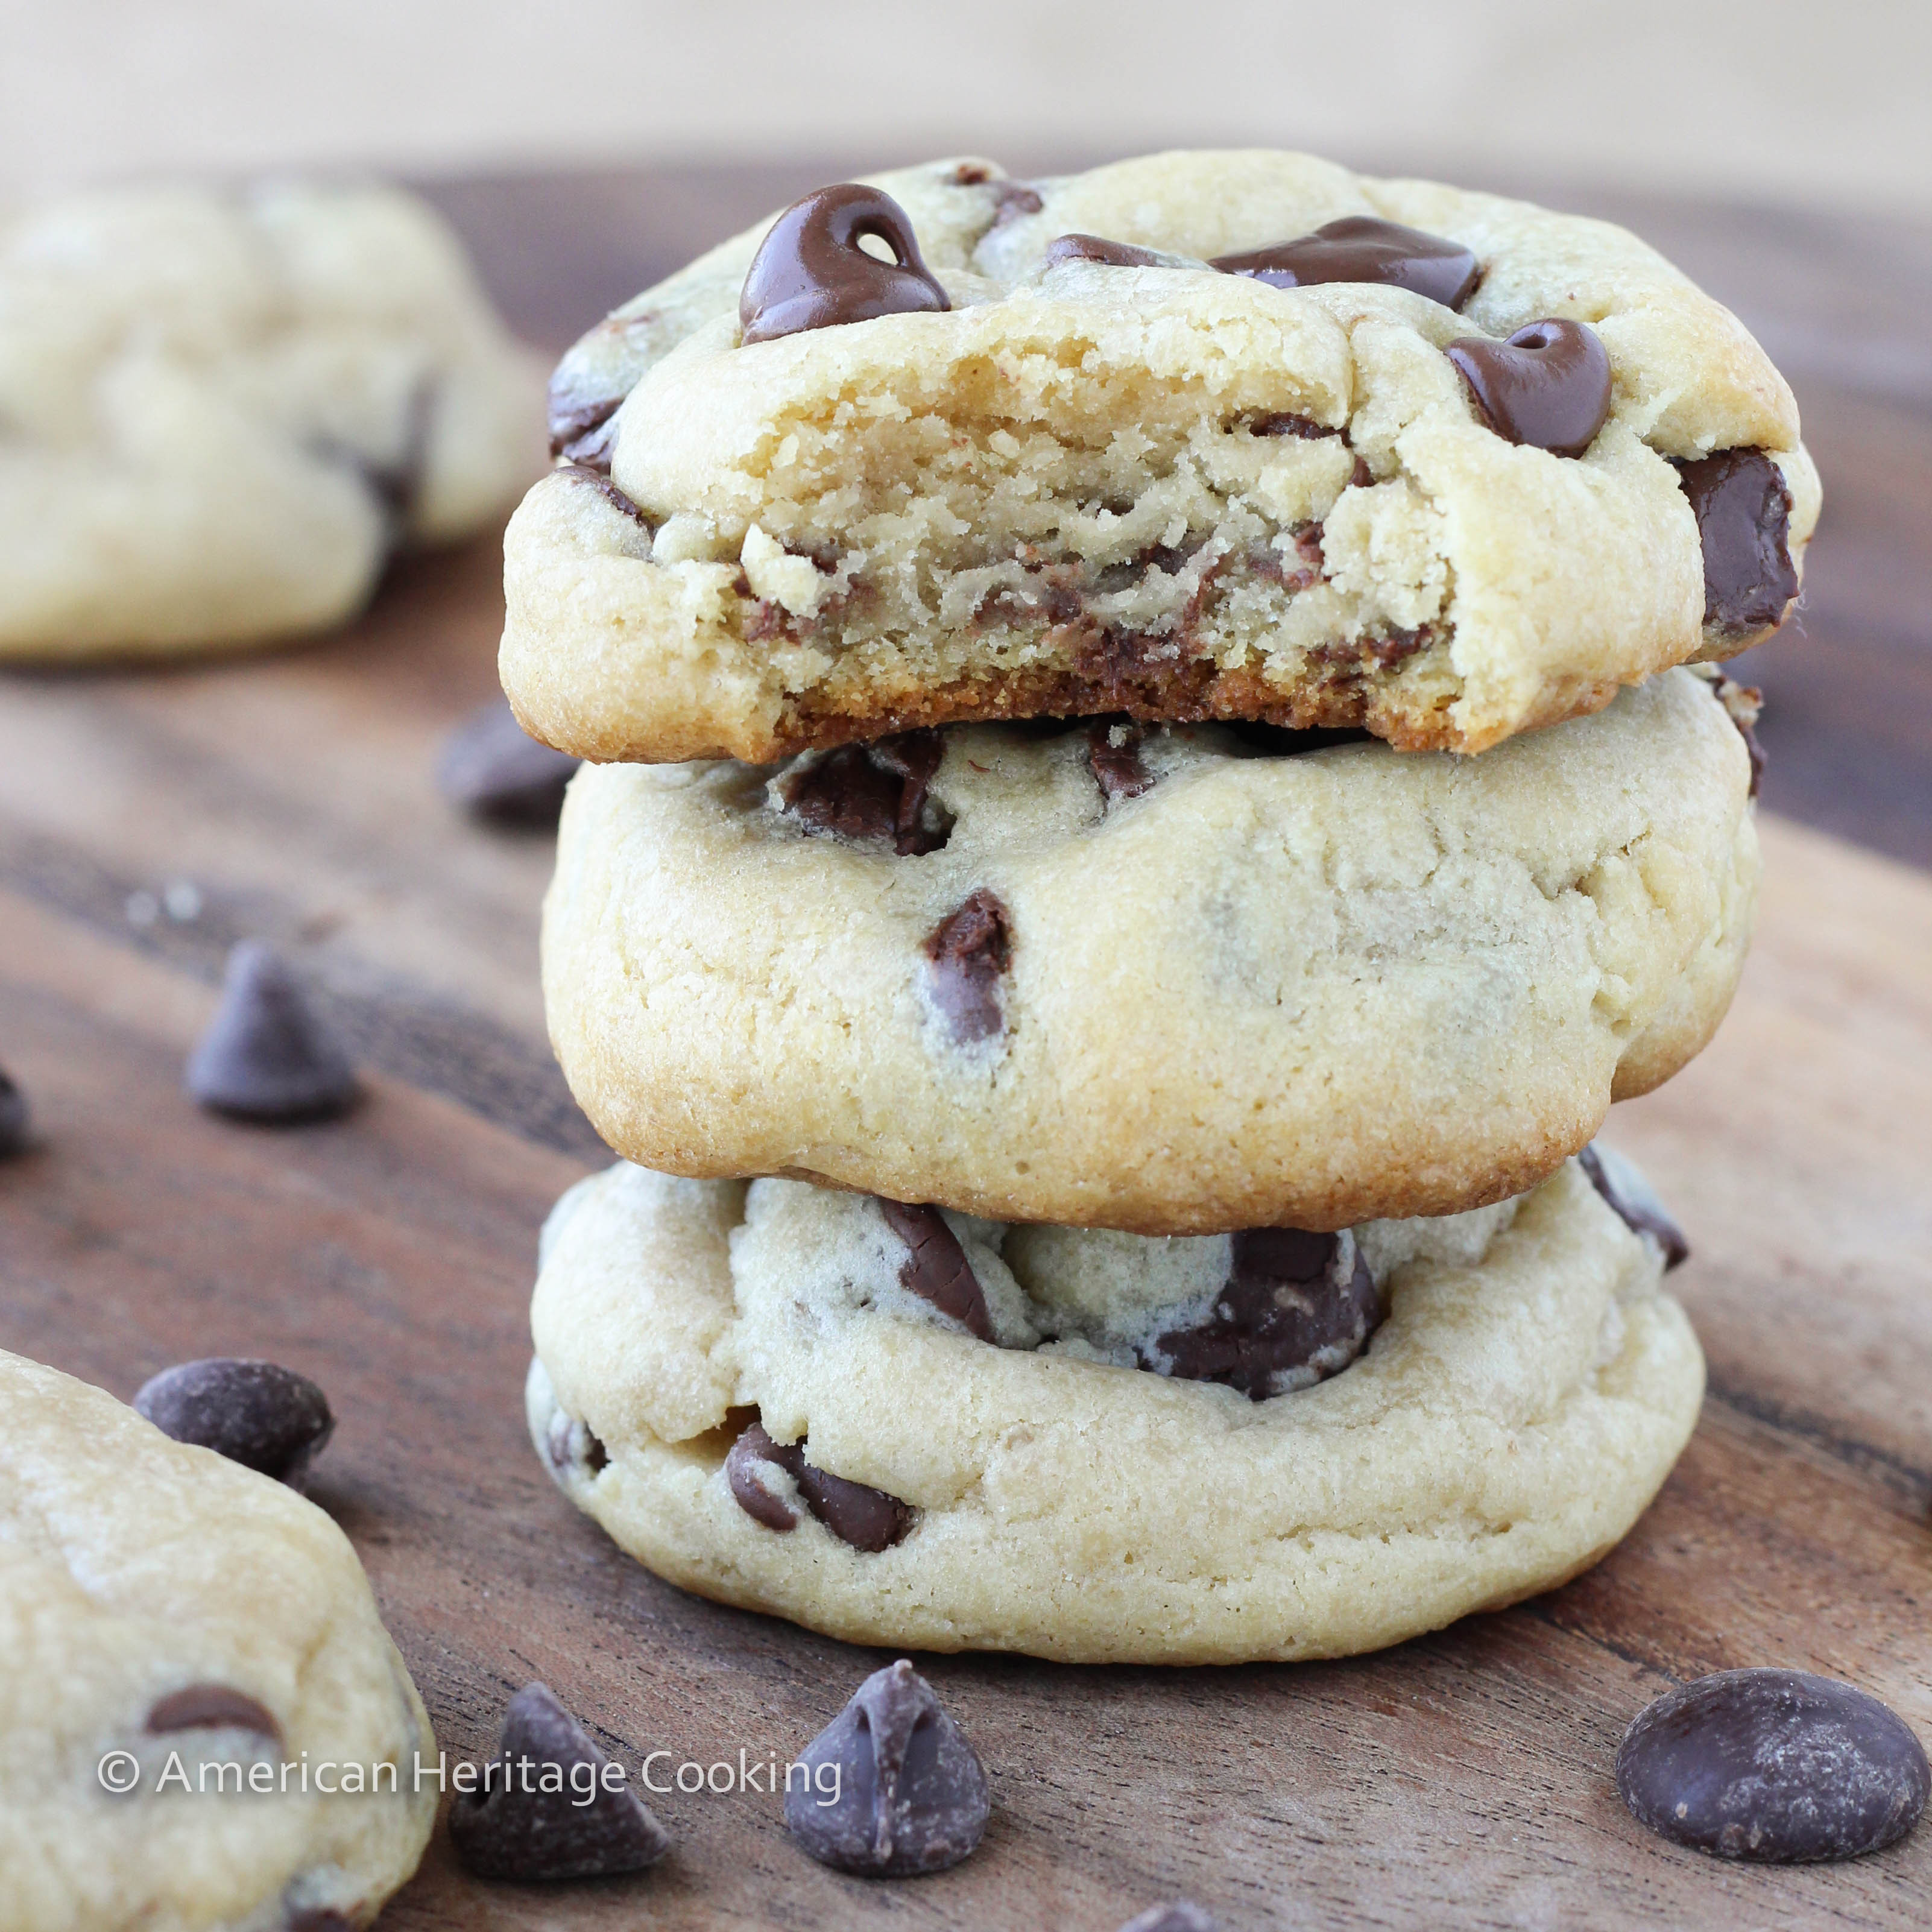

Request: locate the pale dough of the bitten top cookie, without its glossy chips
(502, 151), (1818, 761)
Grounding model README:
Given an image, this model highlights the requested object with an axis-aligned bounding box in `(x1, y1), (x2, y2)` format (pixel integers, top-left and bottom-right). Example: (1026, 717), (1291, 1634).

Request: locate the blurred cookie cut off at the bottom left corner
(0, 1354), (437, 1932)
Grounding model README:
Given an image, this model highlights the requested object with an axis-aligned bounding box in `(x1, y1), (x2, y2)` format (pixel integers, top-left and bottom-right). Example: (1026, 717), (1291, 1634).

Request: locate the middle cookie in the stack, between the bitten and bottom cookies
(543, 671), (1758, 1234)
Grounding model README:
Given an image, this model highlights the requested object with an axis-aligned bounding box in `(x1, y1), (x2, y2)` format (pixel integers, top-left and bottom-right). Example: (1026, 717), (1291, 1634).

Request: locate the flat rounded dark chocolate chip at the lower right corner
(1617, 1669), (1932, 1864)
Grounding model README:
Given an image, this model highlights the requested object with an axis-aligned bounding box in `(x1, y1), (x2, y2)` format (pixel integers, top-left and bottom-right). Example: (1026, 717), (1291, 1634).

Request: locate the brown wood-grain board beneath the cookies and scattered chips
(0, 169), (1932, 1932)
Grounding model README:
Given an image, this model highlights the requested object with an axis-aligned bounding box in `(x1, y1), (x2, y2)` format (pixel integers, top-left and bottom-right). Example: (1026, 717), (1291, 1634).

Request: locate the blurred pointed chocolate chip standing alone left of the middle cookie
(188, 939), (356, 1125)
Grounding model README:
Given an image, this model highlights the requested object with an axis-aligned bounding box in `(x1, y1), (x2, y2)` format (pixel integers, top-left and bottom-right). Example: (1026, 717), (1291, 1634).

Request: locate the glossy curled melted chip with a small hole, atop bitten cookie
(738, 182), (953, 342)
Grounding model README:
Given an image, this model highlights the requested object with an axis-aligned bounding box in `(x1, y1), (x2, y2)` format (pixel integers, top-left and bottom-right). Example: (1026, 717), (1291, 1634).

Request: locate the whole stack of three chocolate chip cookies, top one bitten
(502, 153), (1818, 1661)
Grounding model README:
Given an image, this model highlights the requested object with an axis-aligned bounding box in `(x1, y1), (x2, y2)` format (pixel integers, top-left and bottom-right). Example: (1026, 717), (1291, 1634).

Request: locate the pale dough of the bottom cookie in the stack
(528, 1163), (1704, 1664)
